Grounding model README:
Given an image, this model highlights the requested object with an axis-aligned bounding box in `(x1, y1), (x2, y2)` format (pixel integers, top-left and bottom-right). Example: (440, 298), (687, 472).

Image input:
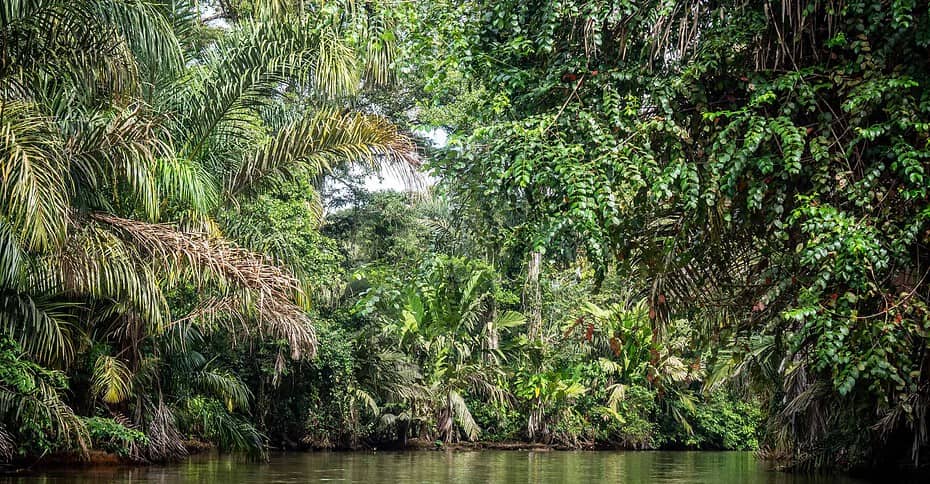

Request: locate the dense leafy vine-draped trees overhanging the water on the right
(404, 0), (930, 467)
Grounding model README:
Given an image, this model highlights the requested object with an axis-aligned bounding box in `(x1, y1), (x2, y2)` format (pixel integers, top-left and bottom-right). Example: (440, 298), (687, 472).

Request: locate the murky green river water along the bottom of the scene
(0, 451), (889, 484)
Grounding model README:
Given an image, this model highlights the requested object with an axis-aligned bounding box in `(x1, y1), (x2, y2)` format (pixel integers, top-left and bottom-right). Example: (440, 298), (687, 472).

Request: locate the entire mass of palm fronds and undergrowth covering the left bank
(0, 0), (417, 466)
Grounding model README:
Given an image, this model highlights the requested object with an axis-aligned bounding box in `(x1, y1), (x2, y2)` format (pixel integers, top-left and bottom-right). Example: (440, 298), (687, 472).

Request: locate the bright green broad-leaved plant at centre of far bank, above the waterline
(376, 256), (524, 442)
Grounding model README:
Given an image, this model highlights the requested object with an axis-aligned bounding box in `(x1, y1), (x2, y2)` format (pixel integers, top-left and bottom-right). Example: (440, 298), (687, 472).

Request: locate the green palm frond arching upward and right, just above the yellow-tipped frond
(165, 16), (357, 160)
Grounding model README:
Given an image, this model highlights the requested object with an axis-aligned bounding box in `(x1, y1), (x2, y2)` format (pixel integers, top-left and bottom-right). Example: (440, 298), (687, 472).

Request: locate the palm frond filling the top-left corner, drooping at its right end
(0, 0), (182, 97)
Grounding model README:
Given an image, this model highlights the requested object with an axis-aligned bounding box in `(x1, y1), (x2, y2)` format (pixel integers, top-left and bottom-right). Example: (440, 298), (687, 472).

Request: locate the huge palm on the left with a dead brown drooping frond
(0, 0), (416, 458)
